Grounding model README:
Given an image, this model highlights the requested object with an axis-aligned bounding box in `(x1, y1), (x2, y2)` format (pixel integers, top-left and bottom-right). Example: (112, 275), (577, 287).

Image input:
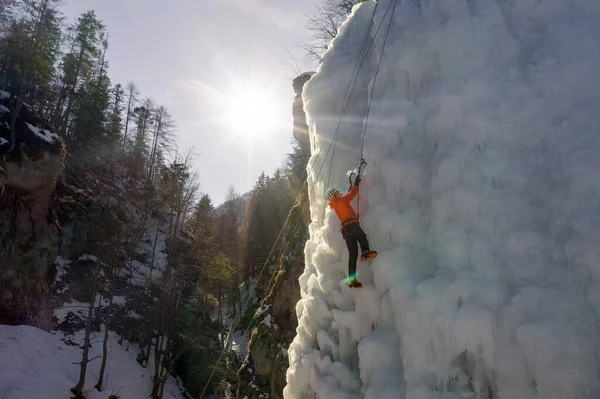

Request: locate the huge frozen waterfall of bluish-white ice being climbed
(284, 0), (600, 399)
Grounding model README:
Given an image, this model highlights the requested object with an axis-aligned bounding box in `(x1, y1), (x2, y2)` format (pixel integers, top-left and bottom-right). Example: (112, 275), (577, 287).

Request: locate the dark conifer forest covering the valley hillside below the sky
(0, 0), (366, 398)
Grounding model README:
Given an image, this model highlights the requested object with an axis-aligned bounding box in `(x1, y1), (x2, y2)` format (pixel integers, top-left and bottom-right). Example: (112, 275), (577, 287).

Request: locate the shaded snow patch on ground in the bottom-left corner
(0, 325), (182, 399)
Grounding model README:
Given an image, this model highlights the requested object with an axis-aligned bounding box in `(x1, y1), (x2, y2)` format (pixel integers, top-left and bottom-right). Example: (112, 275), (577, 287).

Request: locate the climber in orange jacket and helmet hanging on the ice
(327, 174), (377, 288)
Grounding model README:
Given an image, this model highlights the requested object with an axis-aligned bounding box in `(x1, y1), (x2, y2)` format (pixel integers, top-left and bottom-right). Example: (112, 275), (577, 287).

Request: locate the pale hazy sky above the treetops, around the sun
(62, 0), (318, 204)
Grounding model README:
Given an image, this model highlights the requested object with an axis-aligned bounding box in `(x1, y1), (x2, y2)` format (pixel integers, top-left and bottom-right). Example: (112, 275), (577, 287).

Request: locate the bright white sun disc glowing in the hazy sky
(224, 87), (277, 138)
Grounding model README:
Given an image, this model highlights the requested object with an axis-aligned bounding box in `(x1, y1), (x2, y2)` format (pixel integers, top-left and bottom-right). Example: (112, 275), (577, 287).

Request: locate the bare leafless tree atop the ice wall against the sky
(300, 0), (368, 61)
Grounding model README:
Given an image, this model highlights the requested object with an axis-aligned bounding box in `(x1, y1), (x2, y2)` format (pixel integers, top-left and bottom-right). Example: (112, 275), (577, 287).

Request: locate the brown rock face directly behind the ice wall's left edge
(237, 72), (314, 399)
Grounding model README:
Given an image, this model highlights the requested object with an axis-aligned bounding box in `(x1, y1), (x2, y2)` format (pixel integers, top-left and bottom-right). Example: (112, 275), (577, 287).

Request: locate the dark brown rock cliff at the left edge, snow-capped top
(0, 91), (65, 329)
